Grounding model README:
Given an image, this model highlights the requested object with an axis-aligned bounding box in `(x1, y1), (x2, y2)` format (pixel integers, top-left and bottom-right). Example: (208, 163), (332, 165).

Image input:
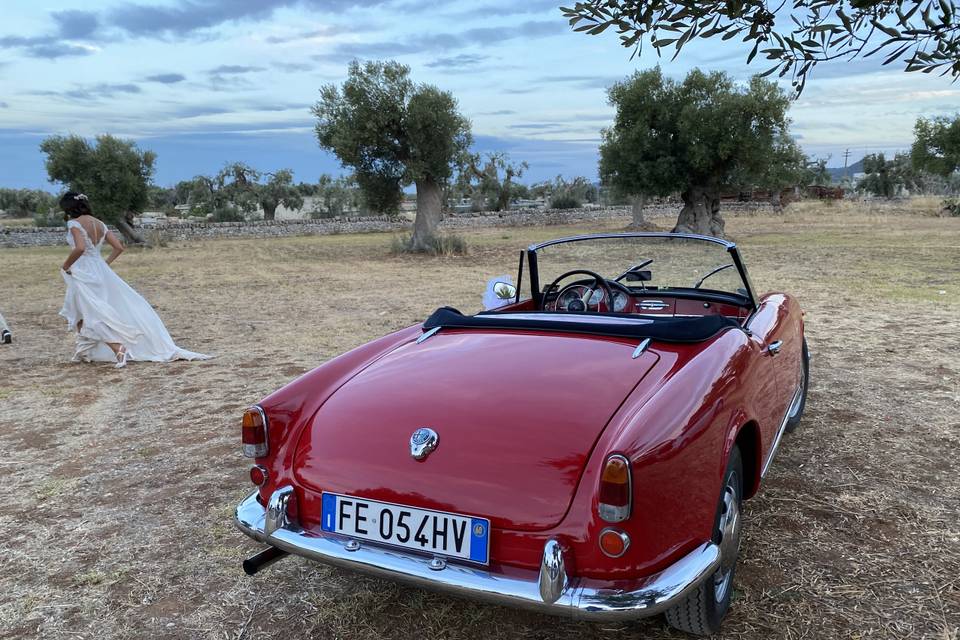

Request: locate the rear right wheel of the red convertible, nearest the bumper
(666, 447), (743, 636)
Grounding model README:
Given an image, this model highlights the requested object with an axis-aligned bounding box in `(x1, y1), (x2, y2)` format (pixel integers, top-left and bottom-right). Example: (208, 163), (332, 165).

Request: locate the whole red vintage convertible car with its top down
(236, 233), (808, 634)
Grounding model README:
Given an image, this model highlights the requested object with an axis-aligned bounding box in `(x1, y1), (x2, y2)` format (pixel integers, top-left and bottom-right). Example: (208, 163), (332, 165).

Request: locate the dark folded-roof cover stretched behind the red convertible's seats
(423, 307), (740, 342)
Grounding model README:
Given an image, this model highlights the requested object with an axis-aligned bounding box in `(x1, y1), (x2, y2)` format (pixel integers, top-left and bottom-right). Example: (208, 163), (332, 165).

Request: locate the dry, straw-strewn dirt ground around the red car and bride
(0, 203), (960, 640)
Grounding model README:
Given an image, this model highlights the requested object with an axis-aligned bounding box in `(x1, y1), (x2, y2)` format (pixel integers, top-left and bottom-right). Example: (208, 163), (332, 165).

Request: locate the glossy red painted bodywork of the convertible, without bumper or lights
(248, 294), (803, 583)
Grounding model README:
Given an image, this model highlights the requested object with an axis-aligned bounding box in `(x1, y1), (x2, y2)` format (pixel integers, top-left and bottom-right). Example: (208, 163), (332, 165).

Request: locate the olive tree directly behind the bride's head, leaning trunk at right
(40, 135), (156, 243)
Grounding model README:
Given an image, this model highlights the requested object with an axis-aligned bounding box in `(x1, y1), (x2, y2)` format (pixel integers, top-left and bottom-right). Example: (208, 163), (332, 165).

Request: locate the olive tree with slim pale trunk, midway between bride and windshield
(313, 60), (472, 251)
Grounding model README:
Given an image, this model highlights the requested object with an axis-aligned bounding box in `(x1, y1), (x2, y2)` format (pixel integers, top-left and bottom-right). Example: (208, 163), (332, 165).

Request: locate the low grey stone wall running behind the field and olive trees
(0, 203), (772, 248)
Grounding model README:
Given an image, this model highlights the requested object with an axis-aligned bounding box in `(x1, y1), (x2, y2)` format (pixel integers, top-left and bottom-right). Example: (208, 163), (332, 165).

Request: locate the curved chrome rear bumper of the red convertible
(236, 487), (720, 620)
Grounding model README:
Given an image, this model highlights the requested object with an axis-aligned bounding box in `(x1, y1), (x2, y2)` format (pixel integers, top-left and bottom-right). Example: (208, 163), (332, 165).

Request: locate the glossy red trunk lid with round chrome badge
(295, 330), (657, 531)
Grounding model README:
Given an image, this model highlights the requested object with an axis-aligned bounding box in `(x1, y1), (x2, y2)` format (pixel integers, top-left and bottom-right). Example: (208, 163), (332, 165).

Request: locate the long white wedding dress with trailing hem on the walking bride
(60, 220), (211, 362)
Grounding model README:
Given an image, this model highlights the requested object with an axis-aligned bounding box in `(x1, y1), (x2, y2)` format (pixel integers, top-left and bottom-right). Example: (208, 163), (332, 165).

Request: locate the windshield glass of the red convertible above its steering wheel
(536, 236), (747, 296)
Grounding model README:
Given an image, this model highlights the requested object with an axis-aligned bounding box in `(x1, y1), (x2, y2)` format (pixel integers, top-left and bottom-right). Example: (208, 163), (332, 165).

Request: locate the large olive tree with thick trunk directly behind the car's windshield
(600, 68), (790, 237)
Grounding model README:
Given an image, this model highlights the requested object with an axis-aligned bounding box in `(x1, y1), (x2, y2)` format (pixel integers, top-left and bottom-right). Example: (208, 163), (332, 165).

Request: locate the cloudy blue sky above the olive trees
(0, 0), (960, 189)
